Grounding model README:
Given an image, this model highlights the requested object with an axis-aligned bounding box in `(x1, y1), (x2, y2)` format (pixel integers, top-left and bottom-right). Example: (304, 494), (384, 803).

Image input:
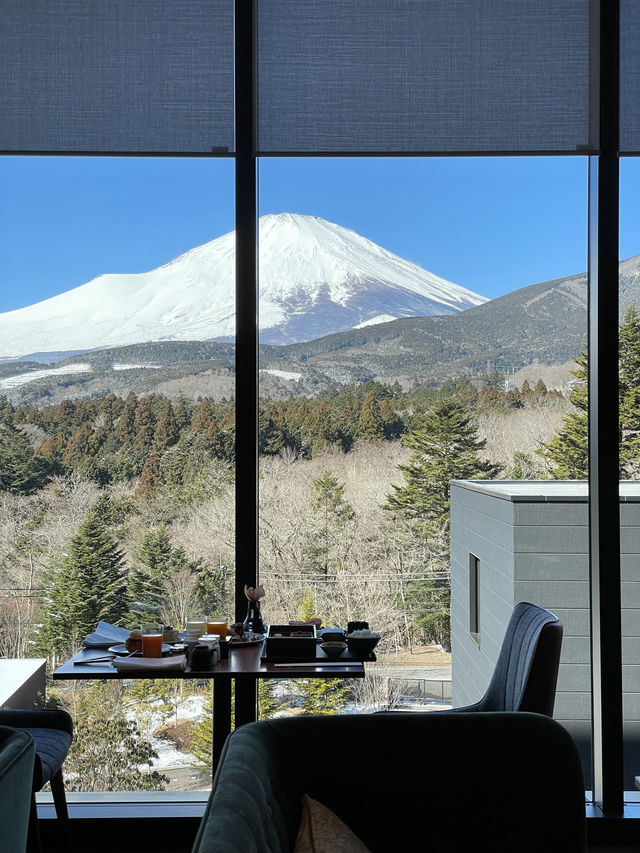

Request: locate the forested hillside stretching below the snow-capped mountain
(0, 256), (640, 405)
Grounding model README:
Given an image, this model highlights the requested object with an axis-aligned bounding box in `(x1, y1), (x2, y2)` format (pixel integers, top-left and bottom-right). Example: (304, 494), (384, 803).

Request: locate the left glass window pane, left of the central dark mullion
(0, 157), (235, 790)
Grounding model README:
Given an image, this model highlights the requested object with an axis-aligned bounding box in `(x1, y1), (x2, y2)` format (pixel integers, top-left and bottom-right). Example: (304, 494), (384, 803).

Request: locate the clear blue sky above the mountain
(0, 157), (640, 311)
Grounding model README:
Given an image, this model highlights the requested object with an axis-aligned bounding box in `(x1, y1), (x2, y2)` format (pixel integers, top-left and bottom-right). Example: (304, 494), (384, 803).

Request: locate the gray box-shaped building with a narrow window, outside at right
(451, 480), (640, 789)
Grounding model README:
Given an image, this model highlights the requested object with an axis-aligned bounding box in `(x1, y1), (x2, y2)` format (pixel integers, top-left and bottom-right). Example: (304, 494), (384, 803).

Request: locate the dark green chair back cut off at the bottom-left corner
(0, 726), (35, 853)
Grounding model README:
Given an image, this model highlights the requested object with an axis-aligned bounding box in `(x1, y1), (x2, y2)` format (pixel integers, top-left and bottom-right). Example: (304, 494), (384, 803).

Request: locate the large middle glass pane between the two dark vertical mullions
(260, 158), (590, 744)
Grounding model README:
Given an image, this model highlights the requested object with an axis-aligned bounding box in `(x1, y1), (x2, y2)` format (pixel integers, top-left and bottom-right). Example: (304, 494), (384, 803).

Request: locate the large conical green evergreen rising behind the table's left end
(38, 497), (127, 654)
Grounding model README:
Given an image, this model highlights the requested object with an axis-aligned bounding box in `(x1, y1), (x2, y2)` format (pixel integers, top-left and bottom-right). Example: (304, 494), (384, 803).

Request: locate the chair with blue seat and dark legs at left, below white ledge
(0, 710), (73, 851)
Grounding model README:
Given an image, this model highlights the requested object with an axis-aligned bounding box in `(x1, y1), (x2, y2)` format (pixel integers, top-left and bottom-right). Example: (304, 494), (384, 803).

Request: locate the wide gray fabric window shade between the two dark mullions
(258, 0), (596, 153)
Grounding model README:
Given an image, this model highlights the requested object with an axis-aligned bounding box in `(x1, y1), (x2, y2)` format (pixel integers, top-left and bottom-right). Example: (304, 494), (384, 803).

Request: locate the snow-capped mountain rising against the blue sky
(0, 213), (486, 358)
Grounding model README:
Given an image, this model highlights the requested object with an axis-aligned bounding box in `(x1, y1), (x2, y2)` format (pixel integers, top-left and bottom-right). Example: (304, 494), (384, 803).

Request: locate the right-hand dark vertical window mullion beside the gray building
(589, 0), (624, 816)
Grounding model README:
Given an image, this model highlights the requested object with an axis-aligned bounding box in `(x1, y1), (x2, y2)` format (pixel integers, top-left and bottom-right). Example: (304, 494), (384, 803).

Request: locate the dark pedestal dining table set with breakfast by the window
(53, 641), (365, 774)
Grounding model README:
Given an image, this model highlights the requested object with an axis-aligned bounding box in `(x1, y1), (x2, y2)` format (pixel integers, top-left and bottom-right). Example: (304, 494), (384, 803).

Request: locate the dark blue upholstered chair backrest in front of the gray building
(478, 601), (562, 717)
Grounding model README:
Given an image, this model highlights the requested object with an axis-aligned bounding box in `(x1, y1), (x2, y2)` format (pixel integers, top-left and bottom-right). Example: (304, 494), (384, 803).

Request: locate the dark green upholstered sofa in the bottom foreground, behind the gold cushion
(193, 712), (586, 853)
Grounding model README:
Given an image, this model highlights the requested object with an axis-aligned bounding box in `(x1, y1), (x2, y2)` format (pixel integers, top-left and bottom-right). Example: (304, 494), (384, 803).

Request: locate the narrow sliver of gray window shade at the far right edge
(620, 0), (640, 154)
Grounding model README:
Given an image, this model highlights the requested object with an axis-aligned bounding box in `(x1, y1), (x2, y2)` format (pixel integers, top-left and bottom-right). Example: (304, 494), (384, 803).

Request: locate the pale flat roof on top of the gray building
(451, 480), (640, 503)
